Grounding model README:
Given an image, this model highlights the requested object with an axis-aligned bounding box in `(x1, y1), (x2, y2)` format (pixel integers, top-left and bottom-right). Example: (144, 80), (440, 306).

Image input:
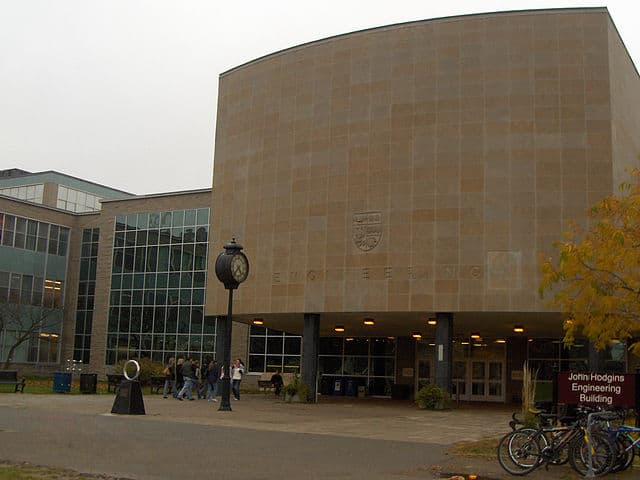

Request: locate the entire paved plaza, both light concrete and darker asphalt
(0, 394), (637, 480)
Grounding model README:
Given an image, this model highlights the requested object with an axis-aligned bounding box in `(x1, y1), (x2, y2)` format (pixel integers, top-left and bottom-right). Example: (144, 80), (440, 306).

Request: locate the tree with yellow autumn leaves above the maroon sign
(539, 169), (640, 355)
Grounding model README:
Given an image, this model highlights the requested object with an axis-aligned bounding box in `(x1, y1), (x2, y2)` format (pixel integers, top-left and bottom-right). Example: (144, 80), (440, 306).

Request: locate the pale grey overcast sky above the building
(0, 0), (640, 194)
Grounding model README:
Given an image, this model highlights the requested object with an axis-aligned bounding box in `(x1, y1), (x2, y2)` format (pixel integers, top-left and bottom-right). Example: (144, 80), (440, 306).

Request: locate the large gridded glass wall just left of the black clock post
(106, 208), (216, 365)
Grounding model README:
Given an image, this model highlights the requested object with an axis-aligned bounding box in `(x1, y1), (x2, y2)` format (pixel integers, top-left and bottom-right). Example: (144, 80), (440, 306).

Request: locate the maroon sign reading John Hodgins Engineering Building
(558, 372), (636, 407)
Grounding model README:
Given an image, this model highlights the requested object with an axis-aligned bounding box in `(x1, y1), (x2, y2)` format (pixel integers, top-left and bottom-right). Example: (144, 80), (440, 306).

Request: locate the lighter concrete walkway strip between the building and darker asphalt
(0, 395), (512, 445)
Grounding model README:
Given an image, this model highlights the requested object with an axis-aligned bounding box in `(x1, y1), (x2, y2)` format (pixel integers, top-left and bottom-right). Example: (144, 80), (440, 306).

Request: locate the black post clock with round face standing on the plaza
(216, 238), (249, 411)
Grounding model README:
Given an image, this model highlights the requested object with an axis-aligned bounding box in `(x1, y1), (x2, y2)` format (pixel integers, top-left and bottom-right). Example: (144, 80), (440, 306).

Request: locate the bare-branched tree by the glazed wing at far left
(0, 301), (62, 370)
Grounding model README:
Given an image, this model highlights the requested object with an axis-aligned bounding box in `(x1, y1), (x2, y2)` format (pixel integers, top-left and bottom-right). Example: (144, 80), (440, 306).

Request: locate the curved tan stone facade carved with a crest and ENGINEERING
(207, 8), (639, 330)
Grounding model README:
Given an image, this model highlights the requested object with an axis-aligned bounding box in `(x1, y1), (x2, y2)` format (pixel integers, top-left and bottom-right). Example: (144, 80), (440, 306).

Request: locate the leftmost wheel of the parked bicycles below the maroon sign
(498, 428), (542, 475)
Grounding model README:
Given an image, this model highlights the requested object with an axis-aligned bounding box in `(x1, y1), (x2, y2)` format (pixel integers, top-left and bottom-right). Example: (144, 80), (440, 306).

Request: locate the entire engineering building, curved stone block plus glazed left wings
(0, 8), (640, 402)
